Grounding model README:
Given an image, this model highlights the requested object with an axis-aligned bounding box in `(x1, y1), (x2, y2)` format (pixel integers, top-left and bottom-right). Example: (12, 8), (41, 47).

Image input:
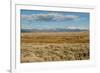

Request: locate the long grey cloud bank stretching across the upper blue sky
(21, 13), (79, 22)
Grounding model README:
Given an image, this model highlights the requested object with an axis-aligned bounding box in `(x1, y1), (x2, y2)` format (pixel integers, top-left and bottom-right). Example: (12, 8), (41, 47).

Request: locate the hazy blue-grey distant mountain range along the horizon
(21, 28), (88, 32)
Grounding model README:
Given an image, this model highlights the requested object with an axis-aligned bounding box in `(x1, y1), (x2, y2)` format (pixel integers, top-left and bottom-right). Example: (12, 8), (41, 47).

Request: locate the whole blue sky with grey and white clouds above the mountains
(20, 9), (90, 29)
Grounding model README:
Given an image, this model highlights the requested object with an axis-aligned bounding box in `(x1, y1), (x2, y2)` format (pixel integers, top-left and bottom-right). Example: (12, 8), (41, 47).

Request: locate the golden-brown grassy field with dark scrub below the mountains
(21, 31), (89, 63)
